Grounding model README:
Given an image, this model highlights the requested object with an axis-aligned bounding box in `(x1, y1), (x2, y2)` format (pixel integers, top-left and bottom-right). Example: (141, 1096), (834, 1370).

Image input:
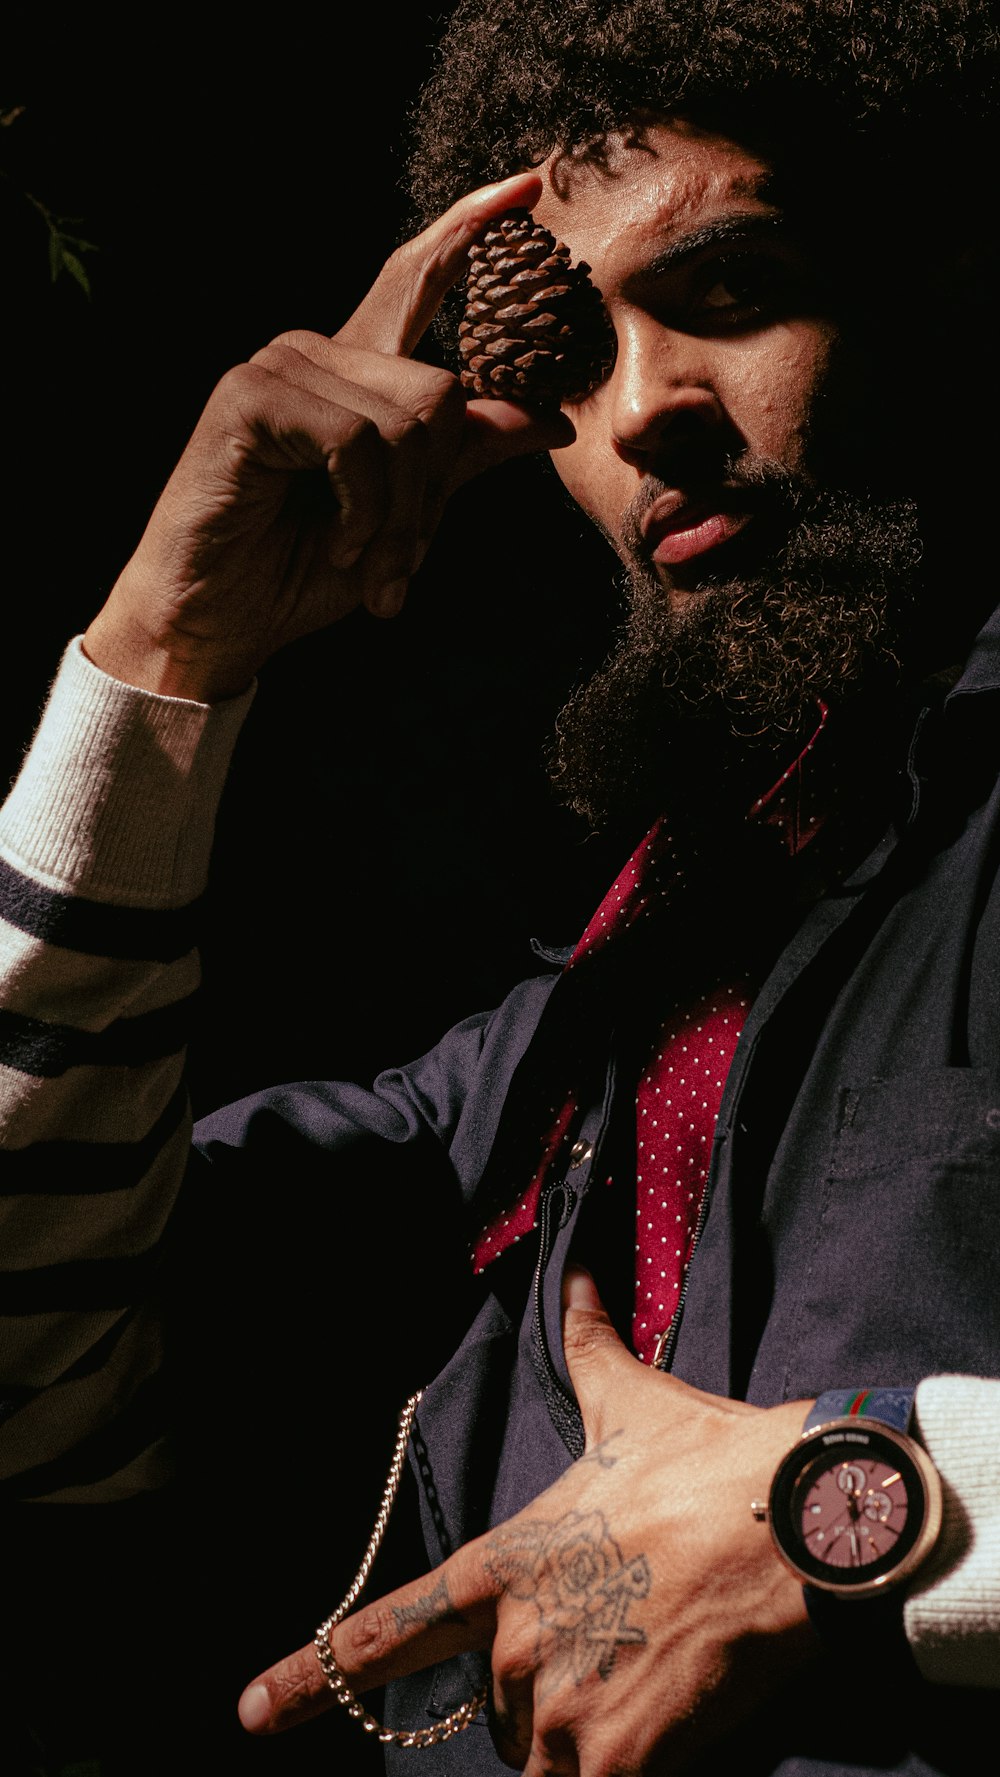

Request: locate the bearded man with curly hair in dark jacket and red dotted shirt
(0, 0), (1000, 1777)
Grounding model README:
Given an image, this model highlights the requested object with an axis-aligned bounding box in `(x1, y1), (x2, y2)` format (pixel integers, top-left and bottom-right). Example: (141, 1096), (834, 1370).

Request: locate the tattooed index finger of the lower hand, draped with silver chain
(240, 1542), (499, 1734)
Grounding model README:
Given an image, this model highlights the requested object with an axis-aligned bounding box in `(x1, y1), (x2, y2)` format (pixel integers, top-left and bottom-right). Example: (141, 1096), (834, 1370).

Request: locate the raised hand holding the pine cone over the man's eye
(83, 172), (574, 700)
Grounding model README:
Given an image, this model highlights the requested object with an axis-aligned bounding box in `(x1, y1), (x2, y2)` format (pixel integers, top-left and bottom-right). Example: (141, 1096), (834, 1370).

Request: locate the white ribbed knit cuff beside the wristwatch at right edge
(906, 1375), (1000, 1688)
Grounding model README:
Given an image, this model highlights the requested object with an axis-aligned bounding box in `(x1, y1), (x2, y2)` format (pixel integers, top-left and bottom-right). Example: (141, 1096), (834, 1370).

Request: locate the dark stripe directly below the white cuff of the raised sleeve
(0, 858), (201, 963)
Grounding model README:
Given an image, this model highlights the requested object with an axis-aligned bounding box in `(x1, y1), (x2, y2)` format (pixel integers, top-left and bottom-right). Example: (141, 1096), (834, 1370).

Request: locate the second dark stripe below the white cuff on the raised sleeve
(0, 993), (197, 1080)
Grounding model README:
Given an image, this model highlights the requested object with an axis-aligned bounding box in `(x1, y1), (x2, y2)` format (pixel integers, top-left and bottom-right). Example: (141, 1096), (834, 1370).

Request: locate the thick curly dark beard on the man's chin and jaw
(549, 460), (924, 832)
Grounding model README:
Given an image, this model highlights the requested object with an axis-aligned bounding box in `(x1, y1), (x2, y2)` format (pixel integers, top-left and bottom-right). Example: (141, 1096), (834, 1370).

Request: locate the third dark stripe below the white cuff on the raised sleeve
(0, 1080), (188, 1201)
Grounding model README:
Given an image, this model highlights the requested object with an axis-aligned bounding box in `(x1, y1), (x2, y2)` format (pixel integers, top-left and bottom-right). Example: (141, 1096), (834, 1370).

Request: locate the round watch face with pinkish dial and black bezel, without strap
(771, 1420), (936, 1592)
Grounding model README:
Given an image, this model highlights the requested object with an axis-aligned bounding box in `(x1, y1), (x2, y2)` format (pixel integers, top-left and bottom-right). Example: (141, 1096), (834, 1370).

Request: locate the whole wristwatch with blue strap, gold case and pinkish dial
(751, 1388), (941, 1624)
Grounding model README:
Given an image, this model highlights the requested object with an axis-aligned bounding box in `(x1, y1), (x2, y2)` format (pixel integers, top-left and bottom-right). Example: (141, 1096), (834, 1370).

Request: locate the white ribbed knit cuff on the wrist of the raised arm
(0, 638), (254, 908)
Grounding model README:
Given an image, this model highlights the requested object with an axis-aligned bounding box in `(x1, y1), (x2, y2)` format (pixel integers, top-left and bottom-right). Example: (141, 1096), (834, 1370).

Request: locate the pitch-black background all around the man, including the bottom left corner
(0, 24), (625, 1777)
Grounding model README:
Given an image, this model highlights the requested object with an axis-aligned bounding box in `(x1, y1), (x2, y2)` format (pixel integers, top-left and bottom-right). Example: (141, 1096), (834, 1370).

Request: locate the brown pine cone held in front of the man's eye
(458, 210), (615, 407)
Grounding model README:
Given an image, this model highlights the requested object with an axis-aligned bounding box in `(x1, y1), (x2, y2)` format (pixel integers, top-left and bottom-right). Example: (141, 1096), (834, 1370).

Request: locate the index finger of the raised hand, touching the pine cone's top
(334, 172), (542, 357)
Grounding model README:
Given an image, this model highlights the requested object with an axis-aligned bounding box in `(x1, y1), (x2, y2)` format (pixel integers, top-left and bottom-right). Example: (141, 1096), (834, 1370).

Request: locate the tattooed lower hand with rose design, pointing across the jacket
(240, 1272), (813, 1777)
